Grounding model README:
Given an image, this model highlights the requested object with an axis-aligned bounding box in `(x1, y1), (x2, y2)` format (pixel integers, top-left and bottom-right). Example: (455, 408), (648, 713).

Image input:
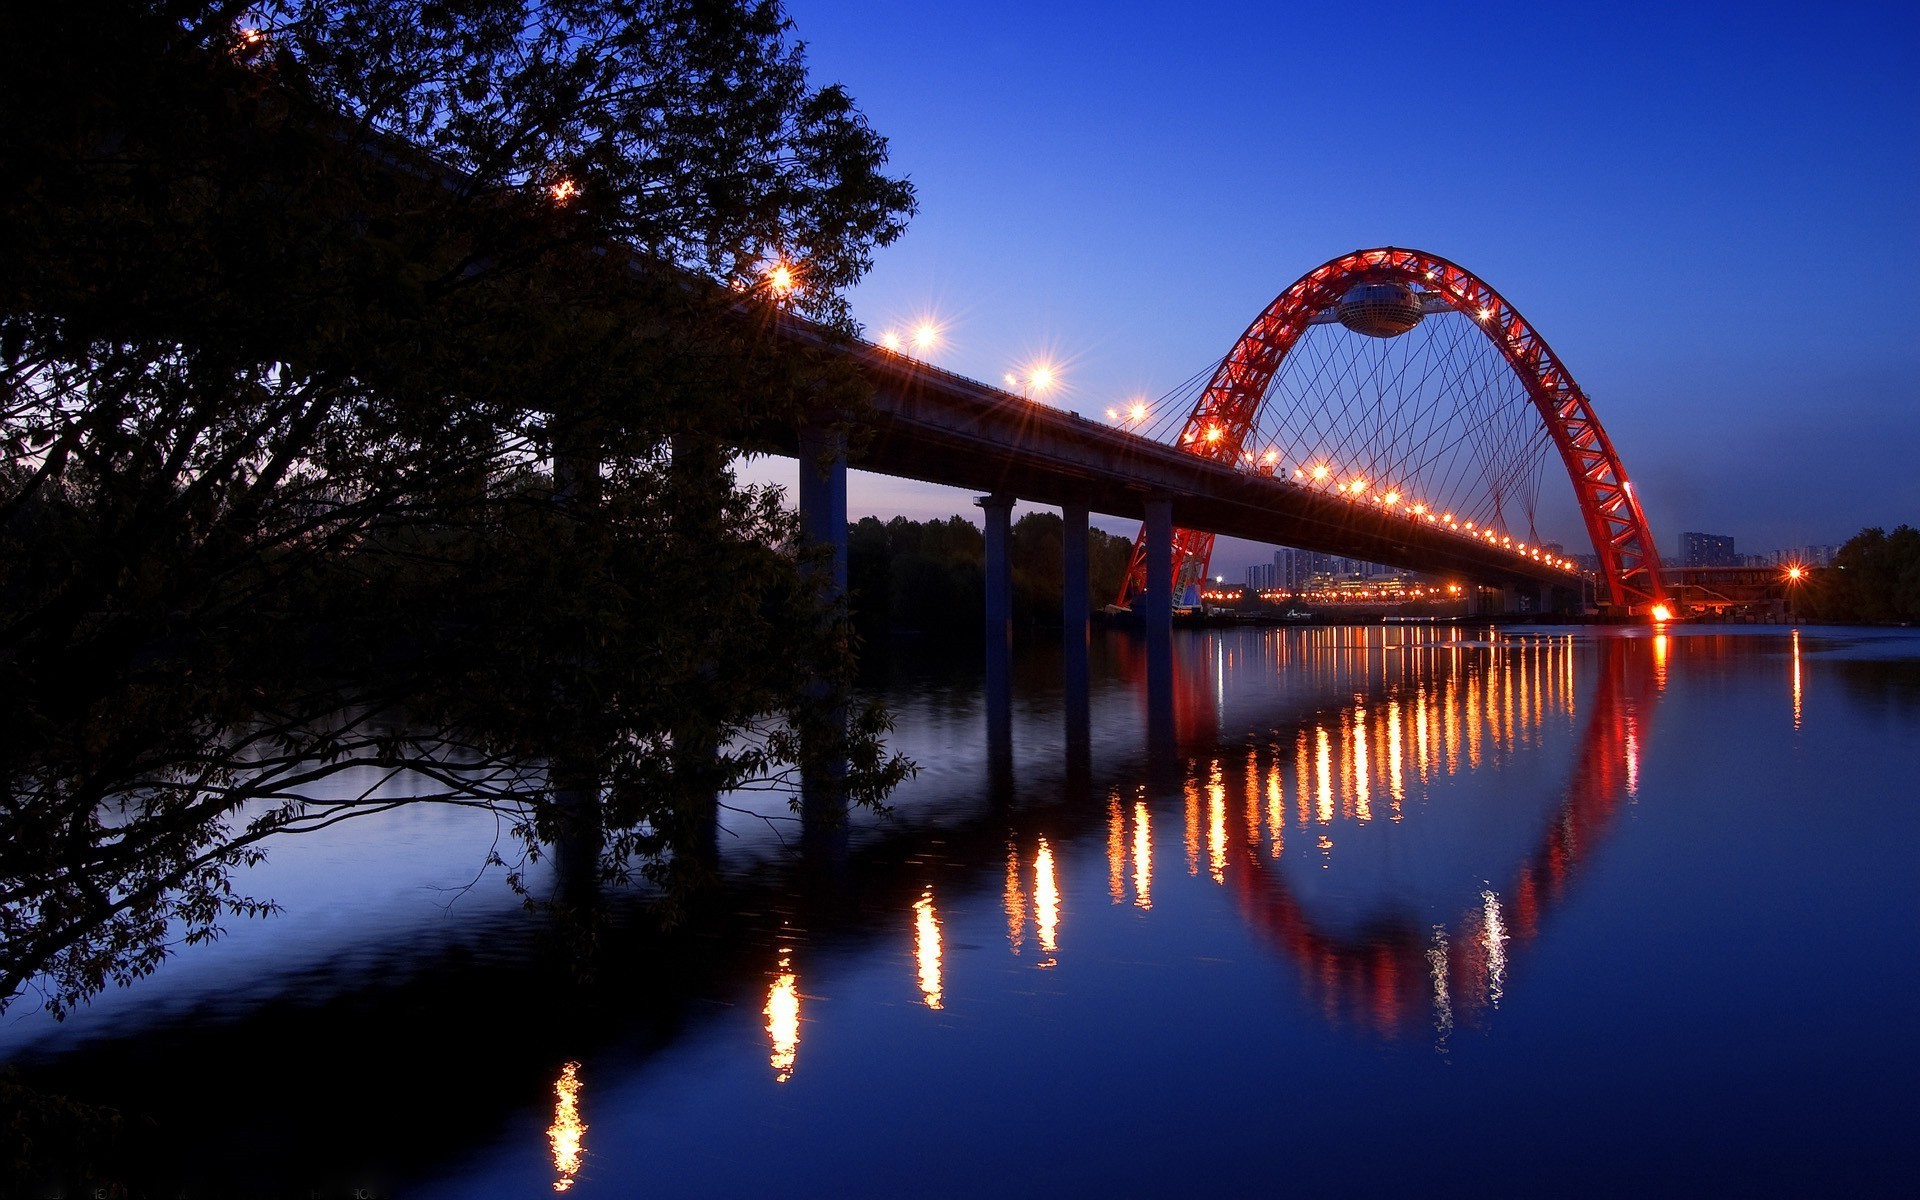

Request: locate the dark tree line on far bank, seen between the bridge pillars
(847, 513), (1133, 637)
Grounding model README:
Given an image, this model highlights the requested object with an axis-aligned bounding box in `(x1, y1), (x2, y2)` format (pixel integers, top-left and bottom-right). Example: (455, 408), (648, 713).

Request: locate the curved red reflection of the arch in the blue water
(1227, 637), (1659, 1035)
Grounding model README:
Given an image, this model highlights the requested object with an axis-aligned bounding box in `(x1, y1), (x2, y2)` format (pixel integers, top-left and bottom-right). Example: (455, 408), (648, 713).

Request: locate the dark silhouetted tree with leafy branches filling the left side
(0, 0), (912, 1012)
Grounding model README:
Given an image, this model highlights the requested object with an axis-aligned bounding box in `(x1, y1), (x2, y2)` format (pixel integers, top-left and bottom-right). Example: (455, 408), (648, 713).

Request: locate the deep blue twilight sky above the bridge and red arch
(751, 0), (1920, 580)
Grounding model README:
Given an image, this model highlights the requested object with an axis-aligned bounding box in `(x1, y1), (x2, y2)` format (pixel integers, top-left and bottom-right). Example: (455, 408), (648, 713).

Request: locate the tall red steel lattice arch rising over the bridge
(1121, 246), (1667, 611)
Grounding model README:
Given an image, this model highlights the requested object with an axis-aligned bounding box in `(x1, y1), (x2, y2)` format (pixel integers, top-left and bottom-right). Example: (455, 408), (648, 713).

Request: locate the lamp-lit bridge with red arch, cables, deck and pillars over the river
(781, 248), (1670, 641)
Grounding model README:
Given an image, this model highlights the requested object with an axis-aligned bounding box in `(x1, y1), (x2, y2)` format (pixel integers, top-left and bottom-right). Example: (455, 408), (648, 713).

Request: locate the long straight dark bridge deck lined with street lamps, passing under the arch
(781, 323), (1580, 591)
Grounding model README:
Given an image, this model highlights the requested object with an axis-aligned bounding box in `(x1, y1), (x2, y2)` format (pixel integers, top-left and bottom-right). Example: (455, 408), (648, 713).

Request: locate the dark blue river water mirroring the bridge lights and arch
(0, 628), (1920, 1198)
